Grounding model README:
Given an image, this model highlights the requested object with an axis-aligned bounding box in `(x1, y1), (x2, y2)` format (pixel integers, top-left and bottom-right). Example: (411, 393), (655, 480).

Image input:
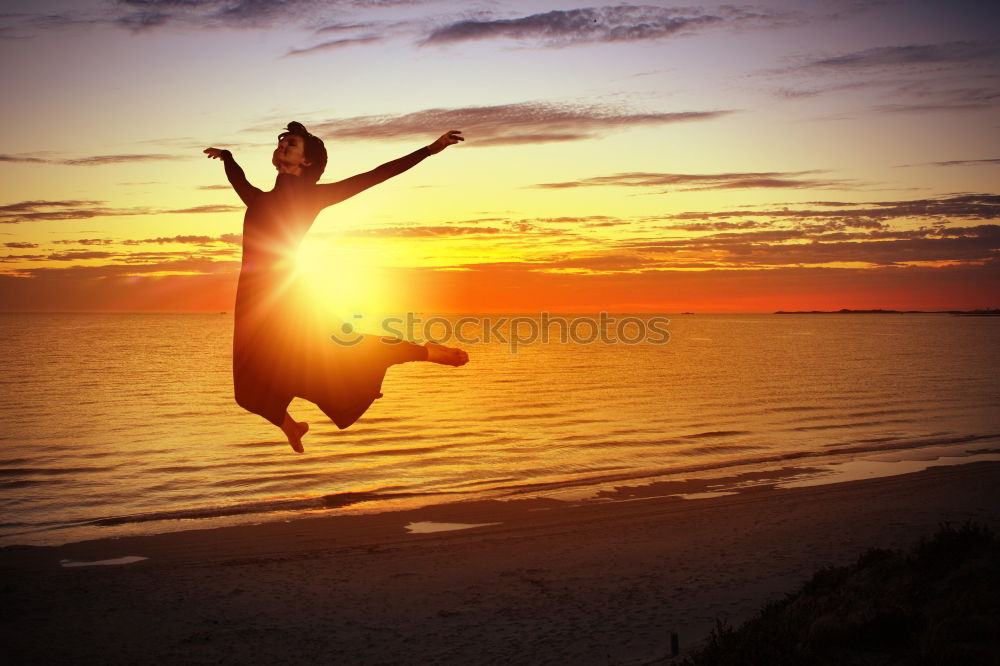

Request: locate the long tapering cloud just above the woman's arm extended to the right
(312, 102), (732, 146)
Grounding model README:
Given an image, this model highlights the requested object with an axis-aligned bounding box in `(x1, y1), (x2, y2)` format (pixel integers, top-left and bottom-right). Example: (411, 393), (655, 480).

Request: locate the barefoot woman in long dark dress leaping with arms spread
(204, 122), (469, 453)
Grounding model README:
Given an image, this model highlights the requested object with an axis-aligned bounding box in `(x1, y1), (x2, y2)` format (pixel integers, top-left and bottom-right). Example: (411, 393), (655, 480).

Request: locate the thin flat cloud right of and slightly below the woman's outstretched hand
(534, 171), (856, 190)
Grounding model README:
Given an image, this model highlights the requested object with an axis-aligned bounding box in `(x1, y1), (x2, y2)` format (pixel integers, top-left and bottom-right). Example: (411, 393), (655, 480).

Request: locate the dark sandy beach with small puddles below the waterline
(0, 462), (1000, 664)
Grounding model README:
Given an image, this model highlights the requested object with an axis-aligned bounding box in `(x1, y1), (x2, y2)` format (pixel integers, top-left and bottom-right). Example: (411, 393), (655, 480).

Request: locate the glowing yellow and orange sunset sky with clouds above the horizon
(0, 0), (1000, 312)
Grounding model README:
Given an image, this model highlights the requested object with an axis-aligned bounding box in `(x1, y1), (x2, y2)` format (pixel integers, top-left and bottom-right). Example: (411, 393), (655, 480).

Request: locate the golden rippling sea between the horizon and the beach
(0, 314), (1000, 544)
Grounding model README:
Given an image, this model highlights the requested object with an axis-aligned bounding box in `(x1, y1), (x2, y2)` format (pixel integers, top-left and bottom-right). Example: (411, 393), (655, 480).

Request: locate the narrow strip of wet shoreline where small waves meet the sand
(0, 434), (1000, 552)
